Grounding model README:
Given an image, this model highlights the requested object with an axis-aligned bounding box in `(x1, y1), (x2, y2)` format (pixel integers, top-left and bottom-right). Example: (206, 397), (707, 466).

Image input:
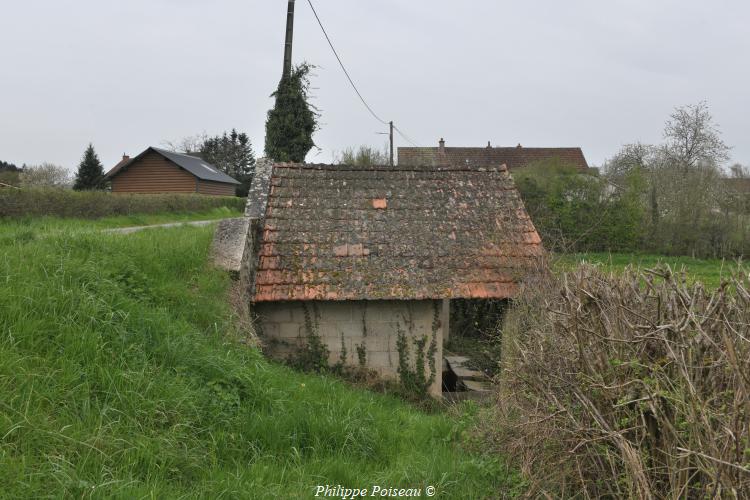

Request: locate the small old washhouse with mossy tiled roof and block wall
(216, 158), (543, 395)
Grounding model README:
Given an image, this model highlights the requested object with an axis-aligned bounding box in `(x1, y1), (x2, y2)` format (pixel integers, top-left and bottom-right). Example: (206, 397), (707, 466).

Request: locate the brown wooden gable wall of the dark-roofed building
(112, 152), (197, 194)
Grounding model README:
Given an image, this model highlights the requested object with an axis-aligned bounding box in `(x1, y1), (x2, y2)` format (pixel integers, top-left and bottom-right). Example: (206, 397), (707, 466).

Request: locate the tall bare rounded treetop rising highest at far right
(664, 101), (730, 170)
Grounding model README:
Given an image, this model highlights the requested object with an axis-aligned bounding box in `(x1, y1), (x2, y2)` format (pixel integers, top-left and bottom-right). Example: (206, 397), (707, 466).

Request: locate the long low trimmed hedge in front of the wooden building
(0, 189), (245, 219)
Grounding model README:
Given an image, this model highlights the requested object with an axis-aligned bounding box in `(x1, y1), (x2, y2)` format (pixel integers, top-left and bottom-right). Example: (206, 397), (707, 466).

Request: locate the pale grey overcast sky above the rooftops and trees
(0, 0), (750, 169)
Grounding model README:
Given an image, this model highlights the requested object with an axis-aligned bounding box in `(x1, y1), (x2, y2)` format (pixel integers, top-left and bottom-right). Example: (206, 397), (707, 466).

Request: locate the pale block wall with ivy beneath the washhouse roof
(255, 300), (443, 396)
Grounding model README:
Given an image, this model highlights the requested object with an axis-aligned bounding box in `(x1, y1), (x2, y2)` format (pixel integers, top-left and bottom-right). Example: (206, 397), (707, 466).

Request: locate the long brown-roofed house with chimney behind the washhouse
(398, 139), (589, 172)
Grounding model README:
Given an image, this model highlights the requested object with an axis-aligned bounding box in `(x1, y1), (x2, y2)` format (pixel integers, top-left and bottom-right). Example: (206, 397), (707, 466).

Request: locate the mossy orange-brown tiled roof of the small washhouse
(251, 164), (544, 302)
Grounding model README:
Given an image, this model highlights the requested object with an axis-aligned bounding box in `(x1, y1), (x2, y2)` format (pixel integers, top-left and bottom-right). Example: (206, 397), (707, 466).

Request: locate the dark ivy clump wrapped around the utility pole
(265, 63), (319, 163)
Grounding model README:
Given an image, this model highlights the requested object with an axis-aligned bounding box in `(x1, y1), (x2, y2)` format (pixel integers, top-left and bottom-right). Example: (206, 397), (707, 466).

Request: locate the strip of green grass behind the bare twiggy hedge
(553, 253), (750, 288)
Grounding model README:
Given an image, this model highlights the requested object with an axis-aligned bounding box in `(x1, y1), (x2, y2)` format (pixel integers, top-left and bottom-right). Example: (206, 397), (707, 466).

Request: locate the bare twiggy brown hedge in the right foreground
(493, 268), (750, 498)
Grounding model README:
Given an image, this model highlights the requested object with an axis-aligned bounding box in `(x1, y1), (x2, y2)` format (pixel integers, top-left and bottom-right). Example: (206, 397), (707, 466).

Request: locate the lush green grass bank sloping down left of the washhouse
(0, 225), (518, 498)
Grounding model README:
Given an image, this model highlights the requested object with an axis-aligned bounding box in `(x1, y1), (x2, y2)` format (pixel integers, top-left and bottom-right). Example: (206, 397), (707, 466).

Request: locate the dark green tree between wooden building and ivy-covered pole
(199, 129), (255, 196)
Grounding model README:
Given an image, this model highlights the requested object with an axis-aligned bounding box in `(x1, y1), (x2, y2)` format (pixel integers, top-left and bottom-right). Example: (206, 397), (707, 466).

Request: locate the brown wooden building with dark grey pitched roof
(105, 147), (240, 196)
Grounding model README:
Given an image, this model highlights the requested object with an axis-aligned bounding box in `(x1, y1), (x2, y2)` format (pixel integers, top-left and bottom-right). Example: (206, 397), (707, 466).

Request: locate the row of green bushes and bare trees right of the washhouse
(513, 103), (750, 258)
